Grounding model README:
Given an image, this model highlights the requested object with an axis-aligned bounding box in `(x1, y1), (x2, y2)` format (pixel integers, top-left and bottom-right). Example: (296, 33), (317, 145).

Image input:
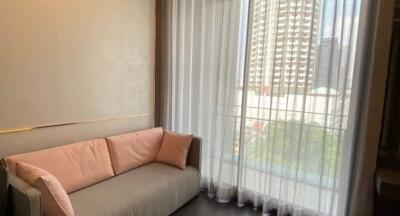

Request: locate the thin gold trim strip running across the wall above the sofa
(0, 113), (151, 134)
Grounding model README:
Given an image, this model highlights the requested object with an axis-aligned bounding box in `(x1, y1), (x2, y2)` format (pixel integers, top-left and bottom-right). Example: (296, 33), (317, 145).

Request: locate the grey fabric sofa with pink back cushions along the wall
(2, 128), (201, 216)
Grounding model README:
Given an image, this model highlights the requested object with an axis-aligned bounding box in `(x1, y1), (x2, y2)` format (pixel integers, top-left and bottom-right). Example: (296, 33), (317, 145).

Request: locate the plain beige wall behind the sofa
(0, 0), (155, 157)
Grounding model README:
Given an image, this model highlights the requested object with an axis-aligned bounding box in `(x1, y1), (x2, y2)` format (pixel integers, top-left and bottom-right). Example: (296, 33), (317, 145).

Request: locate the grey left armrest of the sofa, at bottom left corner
(7, 175), (42, 216)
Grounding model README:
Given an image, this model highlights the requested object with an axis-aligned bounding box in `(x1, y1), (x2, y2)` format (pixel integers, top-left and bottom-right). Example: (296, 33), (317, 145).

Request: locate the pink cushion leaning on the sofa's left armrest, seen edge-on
(15, 162), (74, 216)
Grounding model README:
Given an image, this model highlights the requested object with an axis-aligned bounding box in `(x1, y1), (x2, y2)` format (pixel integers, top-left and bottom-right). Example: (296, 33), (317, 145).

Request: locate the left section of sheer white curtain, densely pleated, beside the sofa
(162, 0), (248, 206)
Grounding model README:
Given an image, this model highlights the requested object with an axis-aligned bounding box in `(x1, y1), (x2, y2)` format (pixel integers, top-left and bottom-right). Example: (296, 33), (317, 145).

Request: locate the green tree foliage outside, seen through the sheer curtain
(245, 120), (343, 177)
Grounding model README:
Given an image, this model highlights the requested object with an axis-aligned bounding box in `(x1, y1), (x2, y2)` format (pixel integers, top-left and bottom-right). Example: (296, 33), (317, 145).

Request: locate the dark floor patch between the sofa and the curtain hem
(172, 192), (261, 216)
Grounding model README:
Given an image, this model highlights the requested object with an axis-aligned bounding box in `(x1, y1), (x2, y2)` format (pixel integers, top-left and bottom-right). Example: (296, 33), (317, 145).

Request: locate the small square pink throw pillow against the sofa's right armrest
(156, 131), (193, 169)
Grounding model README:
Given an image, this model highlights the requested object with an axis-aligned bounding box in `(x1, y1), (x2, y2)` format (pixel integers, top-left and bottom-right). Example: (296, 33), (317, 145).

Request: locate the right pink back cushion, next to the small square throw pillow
(106, 128), (163, 175)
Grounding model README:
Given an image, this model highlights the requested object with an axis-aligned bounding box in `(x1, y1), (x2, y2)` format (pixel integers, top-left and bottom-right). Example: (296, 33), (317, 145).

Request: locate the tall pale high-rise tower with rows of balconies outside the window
(248, 0), (320, 91)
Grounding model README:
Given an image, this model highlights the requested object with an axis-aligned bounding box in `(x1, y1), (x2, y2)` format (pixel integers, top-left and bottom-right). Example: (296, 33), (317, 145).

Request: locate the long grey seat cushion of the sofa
(69, 163), (200, 216)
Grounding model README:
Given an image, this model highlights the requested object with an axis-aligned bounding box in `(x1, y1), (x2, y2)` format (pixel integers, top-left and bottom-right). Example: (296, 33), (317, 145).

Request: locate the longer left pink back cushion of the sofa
(6, 139), (114, 193)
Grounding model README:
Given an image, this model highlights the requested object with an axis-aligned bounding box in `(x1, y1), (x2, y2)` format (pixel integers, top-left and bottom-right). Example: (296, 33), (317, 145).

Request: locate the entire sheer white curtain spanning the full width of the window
(162, 0), (361, 215)
